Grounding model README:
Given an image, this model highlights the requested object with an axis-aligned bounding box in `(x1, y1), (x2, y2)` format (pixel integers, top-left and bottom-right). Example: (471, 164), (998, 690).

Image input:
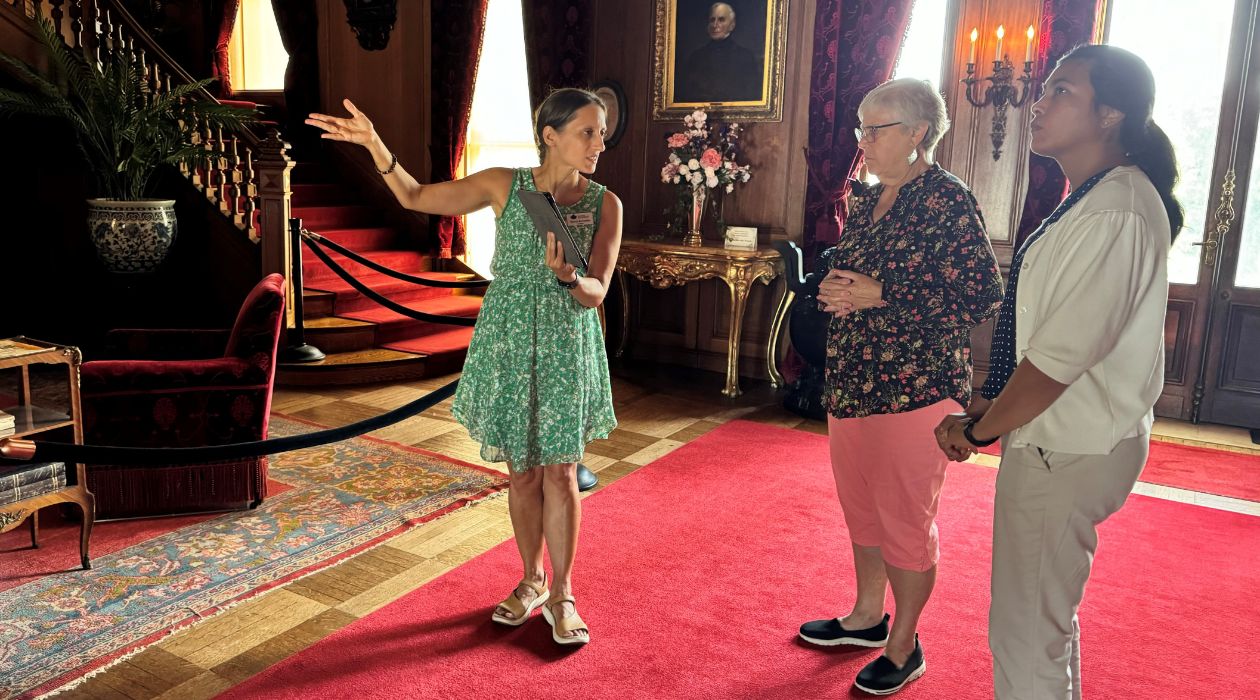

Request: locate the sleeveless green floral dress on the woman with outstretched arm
(451, 167), (617, 472)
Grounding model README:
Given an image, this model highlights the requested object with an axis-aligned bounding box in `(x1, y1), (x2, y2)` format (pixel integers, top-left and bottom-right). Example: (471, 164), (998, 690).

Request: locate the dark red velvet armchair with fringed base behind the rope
(81, 274), (286, 517)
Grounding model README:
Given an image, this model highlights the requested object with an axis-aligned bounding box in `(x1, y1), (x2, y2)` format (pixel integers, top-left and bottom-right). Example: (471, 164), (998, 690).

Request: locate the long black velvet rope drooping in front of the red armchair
(0, 379), (460, 466)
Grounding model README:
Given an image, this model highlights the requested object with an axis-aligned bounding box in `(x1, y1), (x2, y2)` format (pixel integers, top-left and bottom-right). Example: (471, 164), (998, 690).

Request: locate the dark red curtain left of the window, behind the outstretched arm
(430, 0), (488, 258)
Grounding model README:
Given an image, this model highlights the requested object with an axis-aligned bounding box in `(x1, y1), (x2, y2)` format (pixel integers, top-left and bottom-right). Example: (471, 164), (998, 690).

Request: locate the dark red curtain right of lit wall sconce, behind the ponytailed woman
(1014, 0), (1103, 249)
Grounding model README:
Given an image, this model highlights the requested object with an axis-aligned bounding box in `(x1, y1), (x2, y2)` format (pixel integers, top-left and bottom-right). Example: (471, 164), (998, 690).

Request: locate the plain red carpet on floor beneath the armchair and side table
(0, 480), (292, 590)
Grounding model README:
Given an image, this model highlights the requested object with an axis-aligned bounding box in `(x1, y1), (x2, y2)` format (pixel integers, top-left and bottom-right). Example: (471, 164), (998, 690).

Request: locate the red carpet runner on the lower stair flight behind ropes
(292, 164), (481, 374)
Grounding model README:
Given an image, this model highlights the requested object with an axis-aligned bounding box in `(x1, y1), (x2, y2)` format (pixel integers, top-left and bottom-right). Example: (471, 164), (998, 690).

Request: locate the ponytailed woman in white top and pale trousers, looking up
(936, 45), (1183, 700)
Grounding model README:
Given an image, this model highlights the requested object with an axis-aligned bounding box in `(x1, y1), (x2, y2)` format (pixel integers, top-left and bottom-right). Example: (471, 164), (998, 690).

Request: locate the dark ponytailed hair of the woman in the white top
(1058, 44), (1186, 240)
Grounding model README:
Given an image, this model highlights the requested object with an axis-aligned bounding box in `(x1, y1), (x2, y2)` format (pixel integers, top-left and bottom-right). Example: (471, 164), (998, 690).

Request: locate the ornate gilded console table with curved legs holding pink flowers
(617, 239), (794, 399)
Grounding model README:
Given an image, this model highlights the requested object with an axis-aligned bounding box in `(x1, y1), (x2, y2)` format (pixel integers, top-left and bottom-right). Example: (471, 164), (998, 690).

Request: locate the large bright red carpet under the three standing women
(224, 422), (1260, 700)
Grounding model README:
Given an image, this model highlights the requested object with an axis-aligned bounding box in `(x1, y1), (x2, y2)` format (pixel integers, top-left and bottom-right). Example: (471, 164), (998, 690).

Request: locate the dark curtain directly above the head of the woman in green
(520, 0), (595, 108)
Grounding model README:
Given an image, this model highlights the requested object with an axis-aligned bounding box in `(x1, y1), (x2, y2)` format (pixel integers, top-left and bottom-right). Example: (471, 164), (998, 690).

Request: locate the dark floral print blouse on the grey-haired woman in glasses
(824, 165), (1002, 418)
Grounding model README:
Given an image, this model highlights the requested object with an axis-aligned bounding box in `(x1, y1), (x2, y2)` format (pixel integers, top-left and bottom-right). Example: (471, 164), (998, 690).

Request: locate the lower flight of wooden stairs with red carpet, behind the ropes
(276, 164), (481, 385)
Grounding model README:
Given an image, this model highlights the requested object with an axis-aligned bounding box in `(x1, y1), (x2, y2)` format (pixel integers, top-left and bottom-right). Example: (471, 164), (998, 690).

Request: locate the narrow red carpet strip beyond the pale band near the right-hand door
(982, 441), (1260, 501)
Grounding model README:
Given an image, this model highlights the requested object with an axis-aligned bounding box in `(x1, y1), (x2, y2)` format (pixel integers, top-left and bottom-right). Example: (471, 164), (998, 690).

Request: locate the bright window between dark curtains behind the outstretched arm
(459, 0), (538, 277)
